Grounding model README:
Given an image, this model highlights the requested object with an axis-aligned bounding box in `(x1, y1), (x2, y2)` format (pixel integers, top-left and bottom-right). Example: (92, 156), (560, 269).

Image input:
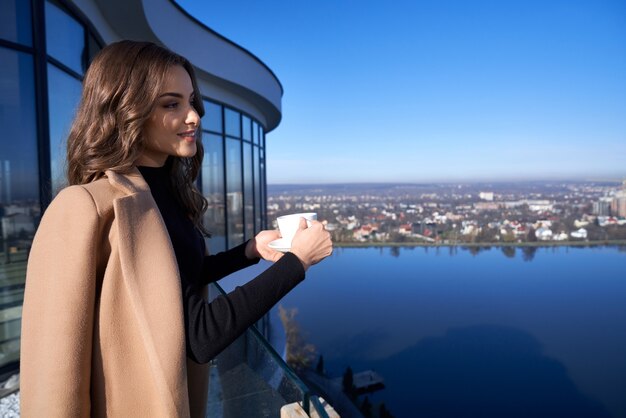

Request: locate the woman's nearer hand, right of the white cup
(290, 218), (333, 271)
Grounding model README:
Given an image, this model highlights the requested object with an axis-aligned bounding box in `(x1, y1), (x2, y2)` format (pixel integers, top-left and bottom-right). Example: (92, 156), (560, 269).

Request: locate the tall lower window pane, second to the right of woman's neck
(226, 138), (243, 248)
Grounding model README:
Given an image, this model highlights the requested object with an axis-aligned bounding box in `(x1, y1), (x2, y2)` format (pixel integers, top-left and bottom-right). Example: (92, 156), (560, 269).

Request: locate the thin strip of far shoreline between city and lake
(333, 240), (626, 248)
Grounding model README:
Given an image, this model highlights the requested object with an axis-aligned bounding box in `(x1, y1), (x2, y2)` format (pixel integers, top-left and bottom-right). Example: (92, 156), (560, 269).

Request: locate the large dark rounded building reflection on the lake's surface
(335, 325), (610, 418)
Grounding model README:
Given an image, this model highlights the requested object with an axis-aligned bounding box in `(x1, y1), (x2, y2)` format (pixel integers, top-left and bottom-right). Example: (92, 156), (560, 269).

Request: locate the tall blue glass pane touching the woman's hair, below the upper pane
(48, 64), (81, 196)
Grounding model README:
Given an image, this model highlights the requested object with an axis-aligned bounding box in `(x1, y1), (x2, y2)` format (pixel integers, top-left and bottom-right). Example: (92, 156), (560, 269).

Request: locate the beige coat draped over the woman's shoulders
(20, 169), (206, 418)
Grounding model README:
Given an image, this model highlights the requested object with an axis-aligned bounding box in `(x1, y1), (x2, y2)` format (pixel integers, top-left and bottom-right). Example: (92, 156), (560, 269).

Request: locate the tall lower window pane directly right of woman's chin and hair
(202, 133), (226, 254)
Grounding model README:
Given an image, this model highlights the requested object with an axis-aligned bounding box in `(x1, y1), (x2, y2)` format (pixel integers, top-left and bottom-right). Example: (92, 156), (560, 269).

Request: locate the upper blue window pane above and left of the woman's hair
(46, 1), (85, 74)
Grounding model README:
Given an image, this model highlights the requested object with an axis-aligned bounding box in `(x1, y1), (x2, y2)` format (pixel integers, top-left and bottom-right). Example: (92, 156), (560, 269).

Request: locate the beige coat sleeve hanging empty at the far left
(20, 186), (100, 417)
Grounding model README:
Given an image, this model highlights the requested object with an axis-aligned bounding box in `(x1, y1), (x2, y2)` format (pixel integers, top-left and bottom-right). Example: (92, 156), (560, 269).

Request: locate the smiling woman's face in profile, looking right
(135, 65), (200, 167)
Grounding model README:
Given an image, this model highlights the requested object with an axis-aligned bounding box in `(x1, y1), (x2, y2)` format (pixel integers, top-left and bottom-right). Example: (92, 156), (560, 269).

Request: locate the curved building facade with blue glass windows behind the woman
(0, 0), (283, 381)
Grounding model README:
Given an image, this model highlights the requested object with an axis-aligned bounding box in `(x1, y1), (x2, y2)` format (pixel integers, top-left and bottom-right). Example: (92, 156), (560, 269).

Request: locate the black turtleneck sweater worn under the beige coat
(138, 164), (304, 363)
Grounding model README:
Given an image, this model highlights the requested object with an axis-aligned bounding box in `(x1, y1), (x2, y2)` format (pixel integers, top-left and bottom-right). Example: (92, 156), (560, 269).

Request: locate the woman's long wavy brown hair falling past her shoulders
(67, 41), (208, 235)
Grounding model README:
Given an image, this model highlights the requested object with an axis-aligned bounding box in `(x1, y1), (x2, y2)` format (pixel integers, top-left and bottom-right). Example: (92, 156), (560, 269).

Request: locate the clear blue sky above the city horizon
(178, 0), (626, 184)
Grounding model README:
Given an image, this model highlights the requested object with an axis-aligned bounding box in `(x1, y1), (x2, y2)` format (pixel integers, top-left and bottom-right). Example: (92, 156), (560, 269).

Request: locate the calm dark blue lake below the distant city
(219, 247), (626, 417)
